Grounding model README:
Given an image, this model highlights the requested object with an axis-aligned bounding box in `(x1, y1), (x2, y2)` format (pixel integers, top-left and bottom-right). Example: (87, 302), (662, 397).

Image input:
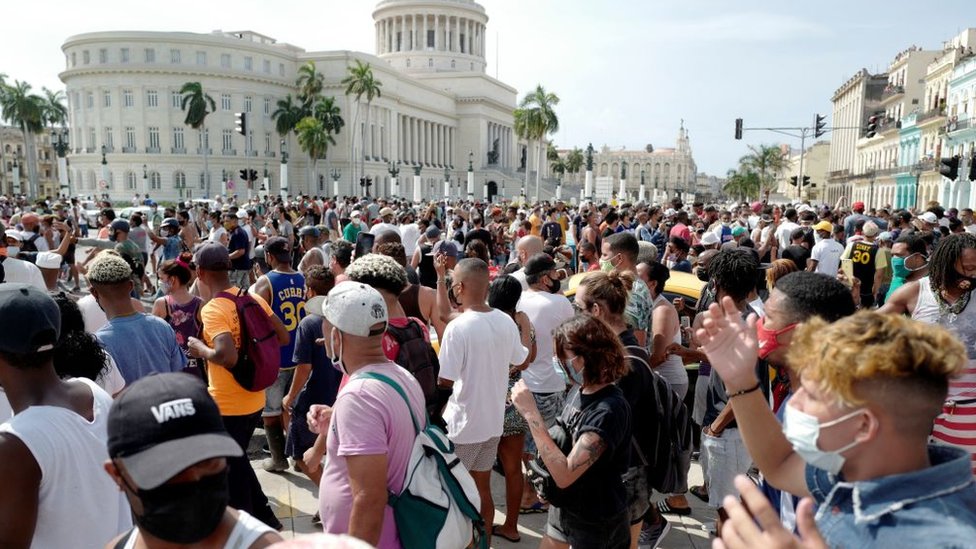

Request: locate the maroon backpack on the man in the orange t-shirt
(217, 290), (281, 392)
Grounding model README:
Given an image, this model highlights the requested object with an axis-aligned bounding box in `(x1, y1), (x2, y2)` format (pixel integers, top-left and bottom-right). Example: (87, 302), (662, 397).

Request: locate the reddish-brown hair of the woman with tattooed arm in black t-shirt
(552, 314), (630, 385)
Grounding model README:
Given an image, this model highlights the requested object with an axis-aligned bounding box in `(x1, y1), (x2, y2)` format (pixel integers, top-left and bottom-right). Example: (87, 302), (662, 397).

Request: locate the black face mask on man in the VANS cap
(135, 468), (230, 544)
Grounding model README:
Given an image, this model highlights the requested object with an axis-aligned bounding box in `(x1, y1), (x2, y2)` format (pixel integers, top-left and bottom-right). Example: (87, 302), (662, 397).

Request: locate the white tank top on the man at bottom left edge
(0, 379), (132, 547)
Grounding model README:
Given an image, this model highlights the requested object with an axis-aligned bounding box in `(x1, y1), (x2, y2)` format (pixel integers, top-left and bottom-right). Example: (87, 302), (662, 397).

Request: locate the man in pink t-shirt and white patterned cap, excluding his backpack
(305, 281), (426, 549)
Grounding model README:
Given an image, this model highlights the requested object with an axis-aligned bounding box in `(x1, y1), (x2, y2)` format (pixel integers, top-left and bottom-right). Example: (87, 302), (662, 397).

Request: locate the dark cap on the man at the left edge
(0, 282), (61, 355)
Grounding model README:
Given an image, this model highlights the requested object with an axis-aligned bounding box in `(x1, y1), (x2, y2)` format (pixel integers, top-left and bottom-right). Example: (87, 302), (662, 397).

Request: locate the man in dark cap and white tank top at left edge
(0, 283), (132, 547)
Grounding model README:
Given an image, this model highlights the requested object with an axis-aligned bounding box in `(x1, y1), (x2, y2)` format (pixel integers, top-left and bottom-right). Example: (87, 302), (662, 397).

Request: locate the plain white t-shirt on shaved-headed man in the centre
(439, 310), (529, 444)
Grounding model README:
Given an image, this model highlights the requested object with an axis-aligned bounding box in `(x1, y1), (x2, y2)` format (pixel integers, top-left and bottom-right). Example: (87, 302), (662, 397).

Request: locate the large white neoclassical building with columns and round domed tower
(60, 0), (521, 200)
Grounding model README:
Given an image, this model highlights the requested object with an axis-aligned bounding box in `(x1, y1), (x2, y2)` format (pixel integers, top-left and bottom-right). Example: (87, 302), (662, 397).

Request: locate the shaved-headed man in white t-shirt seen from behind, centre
(438, 258), (528, 535)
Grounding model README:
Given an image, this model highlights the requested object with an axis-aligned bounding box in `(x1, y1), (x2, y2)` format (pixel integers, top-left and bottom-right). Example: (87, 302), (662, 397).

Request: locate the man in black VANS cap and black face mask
(105, 373), (282, 549)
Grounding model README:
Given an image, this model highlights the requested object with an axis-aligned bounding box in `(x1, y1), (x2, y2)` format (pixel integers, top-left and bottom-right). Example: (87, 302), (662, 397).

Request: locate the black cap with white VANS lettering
(108, 373), (244, 490)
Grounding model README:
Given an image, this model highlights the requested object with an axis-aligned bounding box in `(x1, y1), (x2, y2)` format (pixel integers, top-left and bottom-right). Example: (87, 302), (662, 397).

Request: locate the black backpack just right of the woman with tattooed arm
(626, 346), (692, 494)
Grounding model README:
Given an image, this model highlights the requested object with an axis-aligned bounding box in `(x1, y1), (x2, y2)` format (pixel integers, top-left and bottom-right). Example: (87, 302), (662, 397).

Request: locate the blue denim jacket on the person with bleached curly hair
(806, 445), (976, 549)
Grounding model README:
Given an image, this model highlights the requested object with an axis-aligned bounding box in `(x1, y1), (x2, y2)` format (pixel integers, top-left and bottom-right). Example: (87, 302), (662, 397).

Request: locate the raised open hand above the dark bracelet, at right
(695, 297), (759, 393)
